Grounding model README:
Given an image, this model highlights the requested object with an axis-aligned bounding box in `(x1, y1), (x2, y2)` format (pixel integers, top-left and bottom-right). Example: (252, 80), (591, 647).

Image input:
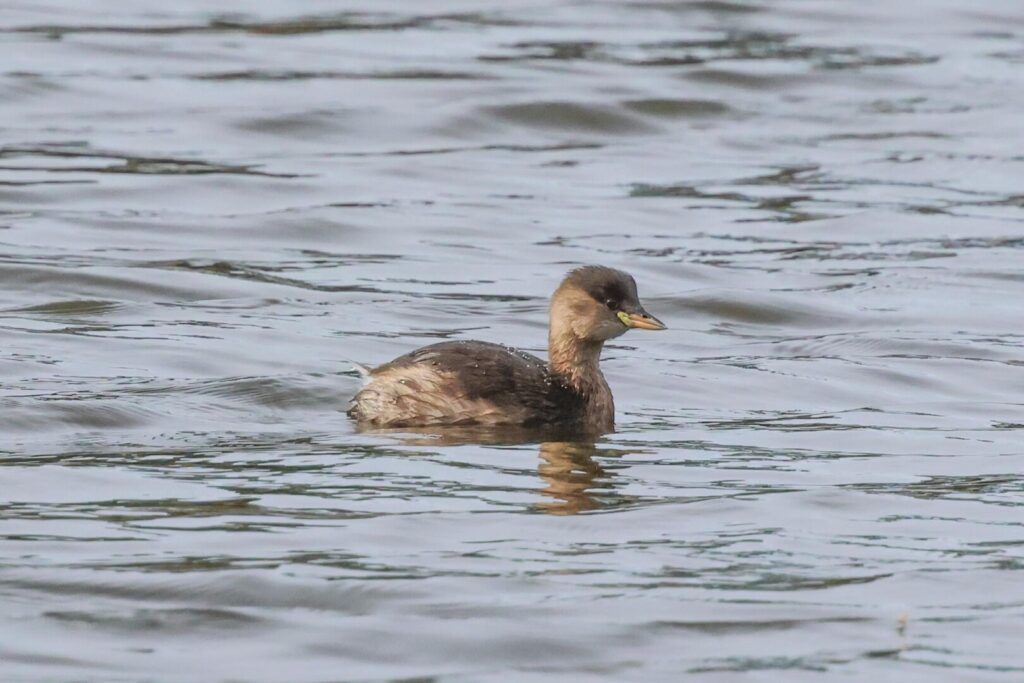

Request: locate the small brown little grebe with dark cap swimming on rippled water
(348, 265), (665, 432)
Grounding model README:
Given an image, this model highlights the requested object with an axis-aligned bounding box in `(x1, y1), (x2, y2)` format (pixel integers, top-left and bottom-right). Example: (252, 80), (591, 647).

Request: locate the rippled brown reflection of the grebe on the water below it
(366, 427), (629, 515)
